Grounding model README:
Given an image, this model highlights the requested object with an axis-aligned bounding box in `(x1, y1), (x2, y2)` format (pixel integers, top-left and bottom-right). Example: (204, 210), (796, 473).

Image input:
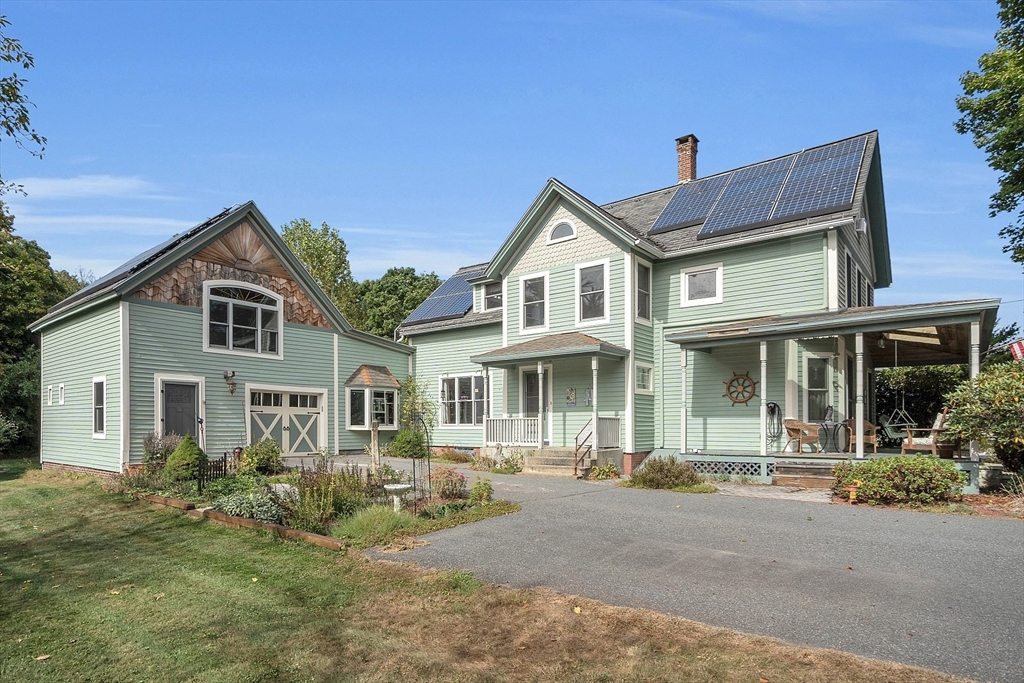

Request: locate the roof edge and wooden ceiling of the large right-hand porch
(666, 299), (999, 368)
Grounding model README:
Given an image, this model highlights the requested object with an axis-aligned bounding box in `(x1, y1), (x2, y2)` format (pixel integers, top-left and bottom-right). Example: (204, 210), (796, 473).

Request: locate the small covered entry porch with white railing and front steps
(470, 332), (629, 455)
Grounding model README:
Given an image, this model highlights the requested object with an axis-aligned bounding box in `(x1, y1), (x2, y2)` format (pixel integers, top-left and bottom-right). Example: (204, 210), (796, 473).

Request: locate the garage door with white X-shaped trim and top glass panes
(249, 389), (325, 456)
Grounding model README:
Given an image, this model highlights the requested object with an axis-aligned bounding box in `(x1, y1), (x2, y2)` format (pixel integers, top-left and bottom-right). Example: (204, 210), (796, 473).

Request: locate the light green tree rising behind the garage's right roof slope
(281, 218), (362, 327)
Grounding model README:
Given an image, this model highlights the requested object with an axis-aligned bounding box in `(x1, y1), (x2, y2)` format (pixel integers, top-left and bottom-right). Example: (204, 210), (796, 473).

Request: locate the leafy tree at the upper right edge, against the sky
(954, 0), (1024, 263)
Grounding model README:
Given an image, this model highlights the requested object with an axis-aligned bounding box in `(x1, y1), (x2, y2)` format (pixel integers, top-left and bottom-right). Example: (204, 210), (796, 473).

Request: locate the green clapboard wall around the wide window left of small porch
(412, 323), (504, 447)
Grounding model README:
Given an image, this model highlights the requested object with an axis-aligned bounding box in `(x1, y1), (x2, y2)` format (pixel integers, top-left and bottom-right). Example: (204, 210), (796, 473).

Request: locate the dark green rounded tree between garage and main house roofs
(359, 267), (441, 339)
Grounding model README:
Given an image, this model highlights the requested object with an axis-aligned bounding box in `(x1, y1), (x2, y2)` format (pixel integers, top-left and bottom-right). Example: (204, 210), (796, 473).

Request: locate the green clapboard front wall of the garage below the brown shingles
(129, 300), (334, 463)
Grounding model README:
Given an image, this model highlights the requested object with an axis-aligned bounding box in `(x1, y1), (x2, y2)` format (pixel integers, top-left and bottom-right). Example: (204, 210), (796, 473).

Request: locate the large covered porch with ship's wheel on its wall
(666, 299), (999, 464)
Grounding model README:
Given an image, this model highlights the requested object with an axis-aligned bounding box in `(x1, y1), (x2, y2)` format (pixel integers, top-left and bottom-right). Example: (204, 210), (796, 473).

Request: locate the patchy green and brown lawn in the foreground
(0, 461), (966, 683)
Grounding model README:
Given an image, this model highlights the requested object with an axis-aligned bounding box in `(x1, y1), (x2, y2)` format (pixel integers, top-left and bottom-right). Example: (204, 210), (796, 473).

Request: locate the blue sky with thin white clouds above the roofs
(0, 0), (1024, 331)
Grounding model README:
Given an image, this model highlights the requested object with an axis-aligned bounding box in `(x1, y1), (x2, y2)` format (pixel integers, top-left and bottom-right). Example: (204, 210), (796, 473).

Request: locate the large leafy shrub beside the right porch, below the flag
(945, 360), (1024, 472)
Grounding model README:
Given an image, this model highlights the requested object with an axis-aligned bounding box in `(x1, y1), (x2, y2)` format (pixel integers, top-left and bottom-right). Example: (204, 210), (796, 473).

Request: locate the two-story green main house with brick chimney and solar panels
(399, 131), (998, 479)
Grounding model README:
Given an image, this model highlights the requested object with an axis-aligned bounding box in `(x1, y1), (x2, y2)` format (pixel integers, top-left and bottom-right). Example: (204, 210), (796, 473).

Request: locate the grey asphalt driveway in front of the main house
(368, 472), (1024, 683)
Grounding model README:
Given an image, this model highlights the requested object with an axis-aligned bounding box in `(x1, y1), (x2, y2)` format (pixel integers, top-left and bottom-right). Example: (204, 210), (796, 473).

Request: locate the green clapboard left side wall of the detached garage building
(40, 303), (121, 472)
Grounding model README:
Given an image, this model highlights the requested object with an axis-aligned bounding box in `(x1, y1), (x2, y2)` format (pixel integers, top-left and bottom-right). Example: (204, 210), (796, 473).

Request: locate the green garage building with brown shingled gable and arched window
(33, 202), (413, 472)
